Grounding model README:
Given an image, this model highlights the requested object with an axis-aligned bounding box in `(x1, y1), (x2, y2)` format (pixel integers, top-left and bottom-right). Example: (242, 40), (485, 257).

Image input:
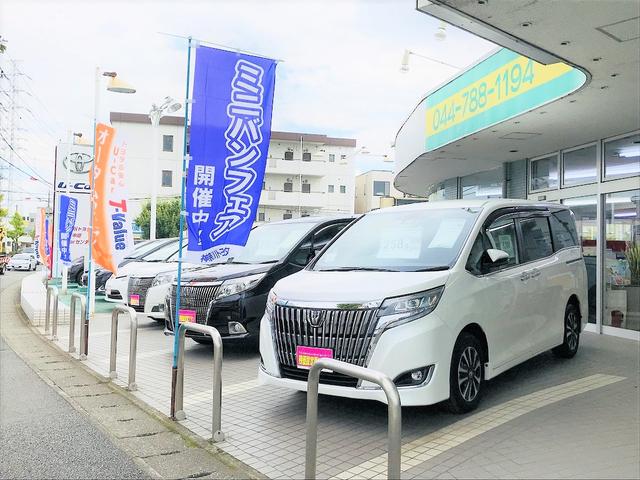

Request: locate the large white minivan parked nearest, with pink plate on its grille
(259, 200), (587, 412)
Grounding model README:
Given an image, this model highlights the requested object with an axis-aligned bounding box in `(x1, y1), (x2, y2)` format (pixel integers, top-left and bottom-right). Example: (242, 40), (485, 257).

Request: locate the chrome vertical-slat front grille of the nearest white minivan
(272, 305), (377, 376)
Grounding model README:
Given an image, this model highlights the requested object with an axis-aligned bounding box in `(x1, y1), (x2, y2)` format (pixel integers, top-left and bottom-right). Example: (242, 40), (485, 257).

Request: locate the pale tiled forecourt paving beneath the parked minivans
(43, 308), (640, 478)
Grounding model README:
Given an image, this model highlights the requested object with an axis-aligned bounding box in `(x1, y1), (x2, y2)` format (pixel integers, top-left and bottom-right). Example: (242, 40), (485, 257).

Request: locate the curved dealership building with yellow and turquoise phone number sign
(394, 0), (640, 340)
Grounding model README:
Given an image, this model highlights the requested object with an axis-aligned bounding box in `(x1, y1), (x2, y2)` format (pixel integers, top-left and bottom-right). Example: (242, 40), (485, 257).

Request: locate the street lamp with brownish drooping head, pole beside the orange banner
(85, 67), (136, 316)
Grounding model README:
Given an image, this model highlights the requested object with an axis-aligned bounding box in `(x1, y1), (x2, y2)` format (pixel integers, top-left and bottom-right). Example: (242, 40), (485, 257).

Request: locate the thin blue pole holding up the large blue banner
(171, 37), (191, 419)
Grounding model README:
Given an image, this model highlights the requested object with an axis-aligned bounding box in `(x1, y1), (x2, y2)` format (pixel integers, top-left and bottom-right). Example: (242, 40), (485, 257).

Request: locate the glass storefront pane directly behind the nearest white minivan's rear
(562, 195), (598, 323)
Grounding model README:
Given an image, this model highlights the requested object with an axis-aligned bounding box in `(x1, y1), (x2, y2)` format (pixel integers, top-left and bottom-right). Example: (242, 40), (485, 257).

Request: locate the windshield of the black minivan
(232, 222), (316, 263)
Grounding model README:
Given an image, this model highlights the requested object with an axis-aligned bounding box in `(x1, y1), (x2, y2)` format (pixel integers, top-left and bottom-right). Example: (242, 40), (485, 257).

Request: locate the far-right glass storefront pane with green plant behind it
(602, 190), (640, 331)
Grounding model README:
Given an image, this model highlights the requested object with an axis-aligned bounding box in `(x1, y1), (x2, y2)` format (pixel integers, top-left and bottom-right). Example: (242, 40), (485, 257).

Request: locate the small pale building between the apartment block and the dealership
(355, 170), (426, 213)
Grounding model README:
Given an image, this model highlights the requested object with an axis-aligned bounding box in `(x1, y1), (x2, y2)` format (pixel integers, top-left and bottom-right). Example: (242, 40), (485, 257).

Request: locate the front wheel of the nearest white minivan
(446, 332), (484, 413)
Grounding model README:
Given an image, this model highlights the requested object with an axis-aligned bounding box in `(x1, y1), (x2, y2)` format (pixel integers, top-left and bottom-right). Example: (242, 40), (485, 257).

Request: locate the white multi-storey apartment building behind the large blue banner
(110, 112), (356, 222)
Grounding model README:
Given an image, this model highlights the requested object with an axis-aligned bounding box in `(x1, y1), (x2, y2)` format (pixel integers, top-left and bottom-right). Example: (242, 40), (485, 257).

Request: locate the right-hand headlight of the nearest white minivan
(378, 286), (444, 329)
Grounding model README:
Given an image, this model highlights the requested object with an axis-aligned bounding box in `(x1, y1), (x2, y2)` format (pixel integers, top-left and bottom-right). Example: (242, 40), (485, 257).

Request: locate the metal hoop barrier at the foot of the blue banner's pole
(175, 322), (224, 442)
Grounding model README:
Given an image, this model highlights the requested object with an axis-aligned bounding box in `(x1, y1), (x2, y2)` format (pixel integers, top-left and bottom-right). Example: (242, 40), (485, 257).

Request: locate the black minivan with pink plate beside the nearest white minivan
(164, 216), (354, 343)
